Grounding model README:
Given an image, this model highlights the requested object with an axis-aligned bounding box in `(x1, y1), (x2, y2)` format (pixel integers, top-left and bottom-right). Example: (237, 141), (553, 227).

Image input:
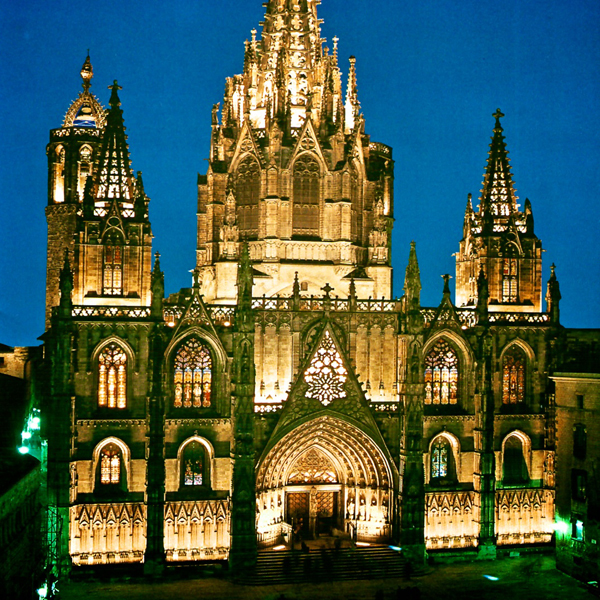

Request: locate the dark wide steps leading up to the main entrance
(236, 546), (407, 585)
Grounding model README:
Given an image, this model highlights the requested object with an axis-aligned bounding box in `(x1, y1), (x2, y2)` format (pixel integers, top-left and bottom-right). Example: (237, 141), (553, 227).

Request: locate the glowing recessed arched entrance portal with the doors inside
(256, 417), (393, 546)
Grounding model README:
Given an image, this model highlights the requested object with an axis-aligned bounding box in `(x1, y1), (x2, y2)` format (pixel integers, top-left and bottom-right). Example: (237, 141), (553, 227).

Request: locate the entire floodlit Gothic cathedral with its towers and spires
(43, 0), (564, 570)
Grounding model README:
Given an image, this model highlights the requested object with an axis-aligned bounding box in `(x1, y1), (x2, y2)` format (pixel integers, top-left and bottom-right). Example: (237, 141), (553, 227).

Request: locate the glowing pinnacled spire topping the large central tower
(222, 0), (360, 133)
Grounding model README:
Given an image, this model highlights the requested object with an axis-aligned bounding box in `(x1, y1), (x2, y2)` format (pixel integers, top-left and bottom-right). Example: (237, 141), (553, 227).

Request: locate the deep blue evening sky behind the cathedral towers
(0, 0), (600, 345)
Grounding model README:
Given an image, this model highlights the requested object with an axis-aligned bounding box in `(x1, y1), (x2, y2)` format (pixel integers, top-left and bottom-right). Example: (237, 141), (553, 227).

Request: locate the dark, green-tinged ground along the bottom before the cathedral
(59, 555), (594, 600)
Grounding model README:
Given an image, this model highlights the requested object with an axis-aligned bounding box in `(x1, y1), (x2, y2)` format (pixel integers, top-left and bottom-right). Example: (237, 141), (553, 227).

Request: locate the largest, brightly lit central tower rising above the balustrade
(196, 0), (393, 302)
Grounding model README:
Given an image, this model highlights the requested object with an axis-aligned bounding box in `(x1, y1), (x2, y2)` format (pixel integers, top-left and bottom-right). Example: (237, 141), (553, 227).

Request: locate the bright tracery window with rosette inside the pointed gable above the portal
(304, 330), (348, 406)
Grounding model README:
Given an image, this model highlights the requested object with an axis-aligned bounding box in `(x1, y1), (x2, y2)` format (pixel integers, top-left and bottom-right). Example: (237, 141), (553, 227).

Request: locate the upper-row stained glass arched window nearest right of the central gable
(425, 340), (458, 404)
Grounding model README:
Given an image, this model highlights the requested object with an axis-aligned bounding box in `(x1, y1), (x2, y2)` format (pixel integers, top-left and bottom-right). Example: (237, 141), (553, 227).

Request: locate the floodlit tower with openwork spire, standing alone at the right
(456, 109), (542, 312)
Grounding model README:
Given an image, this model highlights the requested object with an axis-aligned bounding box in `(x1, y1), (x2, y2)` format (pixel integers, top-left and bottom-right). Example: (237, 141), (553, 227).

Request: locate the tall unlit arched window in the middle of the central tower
(292, 155), (321, 237)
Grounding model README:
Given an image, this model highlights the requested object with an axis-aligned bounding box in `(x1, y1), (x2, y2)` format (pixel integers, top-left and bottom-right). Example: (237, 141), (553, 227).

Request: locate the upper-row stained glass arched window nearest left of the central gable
(174, 338), (212, 408)
